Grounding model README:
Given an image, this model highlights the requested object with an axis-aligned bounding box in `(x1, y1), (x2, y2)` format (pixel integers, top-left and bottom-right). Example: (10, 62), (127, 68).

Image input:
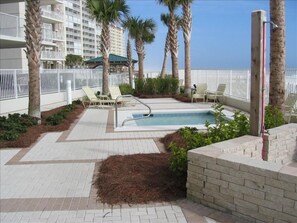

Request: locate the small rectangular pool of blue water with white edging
(115, 109), (233, 131)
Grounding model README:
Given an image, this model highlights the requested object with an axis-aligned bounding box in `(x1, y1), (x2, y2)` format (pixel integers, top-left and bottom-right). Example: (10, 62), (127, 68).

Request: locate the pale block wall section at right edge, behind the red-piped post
(264, 123), (297, 165)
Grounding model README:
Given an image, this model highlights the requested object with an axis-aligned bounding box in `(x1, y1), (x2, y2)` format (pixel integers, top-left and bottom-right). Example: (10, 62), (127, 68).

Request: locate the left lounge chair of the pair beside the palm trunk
(82, 86), (115, 108)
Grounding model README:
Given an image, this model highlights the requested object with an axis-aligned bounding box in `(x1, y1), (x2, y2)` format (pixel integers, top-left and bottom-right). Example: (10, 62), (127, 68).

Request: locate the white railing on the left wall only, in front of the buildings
(0, 69), (129, 100)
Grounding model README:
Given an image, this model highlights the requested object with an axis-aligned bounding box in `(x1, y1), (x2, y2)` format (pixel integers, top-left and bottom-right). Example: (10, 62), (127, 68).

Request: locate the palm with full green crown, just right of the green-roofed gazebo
(124, 17), (156, 79)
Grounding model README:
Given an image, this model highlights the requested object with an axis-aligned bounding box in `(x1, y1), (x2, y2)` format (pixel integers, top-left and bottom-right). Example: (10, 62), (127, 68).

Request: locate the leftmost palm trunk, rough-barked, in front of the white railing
(25, 0), (42, 120)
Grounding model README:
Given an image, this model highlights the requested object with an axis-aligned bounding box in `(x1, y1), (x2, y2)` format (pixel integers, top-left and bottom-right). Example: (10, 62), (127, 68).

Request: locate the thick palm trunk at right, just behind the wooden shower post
(269, 0), (285, 109)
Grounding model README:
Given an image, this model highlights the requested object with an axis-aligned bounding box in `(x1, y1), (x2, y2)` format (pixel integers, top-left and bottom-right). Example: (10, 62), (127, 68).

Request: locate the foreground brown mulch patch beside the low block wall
(94, 153), (186, 205)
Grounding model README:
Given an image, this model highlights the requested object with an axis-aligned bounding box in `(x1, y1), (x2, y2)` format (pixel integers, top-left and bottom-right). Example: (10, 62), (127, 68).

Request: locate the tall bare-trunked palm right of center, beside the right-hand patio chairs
(180, 0), (193, 96)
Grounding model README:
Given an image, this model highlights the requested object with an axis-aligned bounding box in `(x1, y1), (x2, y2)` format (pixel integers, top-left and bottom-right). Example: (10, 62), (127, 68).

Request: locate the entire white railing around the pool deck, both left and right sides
(0, 68), (297, 101)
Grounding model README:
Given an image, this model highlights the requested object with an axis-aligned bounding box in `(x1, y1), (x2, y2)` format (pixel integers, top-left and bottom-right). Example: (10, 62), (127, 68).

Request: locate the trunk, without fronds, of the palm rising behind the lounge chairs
(101, 23), (110, 94)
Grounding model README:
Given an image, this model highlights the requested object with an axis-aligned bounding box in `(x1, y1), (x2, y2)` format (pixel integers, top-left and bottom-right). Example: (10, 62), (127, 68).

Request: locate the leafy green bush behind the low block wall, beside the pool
(169, 104), (250, 176)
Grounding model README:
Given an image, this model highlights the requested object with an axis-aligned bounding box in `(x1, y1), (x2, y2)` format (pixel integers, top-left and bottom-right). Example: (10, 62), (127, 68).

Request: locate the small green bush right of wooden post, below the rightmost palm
(264, 105), (286, 129)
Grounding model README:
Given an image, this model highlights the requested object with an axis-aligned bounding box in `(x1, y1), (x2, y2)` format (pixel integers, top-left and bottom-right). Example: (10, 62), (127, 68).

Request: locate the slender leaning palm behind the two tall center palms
(160, 13), (182, 78)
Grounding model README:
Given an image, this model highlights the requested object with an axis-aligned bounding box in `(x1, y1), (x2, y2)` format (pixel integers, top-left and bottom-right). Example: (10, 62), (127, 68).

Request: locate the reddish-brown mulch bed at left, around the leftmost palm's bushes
(0, 105), (84, 148)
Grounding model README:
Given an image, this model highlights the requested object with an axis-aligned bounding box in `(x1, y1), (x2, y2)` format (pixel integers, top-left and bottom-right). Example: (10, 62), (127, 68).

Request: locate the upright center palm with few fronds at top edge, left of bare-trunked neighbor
(158, 0), (179, 78)
